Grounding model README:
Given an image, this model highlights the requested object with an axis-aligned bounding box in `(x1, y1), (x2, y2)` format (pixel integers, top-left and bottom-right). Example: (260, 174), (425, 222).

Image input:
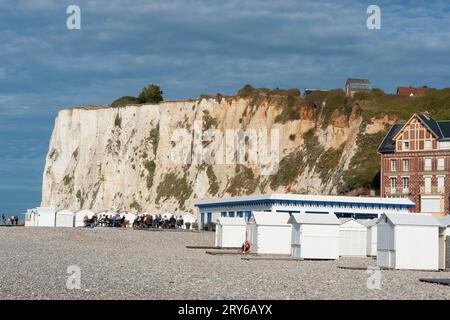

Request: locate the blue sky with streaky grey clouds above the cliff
(0, 0), (450, 214)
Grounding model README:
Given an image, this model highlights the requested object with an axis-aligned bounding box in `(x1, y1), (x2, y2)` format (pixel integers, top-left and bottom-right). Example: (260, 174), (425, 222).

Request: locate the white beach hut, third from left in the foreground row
(288, 213), (340, 260)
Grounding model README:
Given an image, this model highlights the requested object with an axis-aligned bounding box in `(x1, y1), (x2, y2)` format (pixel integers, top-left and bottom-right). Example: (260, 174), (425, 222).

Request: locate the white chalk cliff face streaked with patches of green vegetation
(41, 92), (393, 212)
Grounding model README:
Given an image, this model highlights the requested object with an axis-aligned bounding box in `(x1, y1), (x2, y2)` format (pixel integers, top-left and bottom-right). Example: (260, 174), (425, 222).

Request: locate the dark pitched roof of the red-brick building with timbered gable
(378, 113), (450, 153)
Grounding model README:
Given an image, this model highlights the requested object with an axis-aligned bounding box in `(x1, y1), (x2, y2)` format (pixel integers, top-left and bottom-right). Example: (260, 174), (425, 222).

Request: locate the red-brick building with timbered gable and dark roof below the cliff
(378, 113), (450, 216)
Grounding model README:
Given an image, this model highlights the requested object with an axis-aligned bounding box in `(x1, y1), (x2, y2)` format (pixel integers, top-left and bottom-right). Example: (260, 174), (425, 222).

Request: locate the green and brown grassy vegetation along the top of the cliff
(236, 85), (450, 127)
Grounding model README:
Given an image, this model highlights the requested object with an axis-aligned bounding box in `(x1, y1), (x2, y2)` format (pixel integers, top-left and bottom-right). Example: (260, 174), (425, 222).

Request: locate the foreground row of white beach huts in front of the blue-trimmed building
(215, 212), (450, 270)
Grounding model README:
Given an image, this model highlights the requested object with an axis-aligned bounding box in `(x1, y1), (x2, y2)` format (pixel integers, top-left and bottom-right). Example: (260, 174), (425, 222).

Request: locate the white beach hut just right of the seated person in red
(247, 212), (292, 255)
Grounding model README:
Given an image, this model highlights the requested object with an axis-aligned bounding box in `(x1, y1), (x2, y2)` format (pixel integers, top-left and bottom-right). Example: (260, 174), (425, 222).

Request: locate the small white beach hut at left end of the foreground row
(215, 217), (247, 248)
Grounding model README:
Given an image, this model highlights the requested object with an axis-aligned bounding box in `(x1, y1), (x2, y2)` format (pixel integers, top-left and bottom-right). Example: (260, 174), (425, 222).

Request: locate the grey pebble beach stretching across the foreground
(0, 227), (450, 300)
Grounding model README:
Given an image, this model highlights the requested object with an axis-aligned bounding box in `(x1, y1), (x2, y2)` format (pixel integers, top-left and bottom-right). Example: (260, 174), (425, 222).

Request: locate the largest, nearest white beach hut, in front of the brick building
(377, 213), (445, 270)
